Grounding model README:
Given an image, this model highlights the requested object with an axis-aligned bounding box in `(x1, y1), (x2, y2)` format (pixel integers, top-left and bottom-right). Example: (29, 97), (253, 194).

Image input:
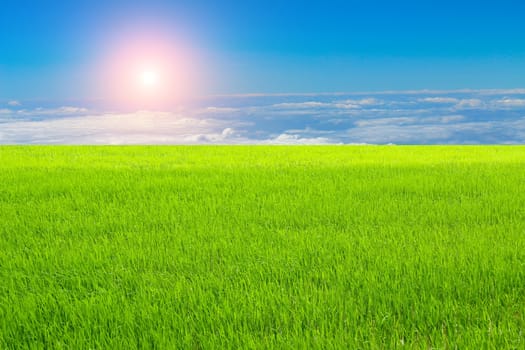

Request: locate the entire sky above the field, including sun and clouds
(0, 0), (525, 144)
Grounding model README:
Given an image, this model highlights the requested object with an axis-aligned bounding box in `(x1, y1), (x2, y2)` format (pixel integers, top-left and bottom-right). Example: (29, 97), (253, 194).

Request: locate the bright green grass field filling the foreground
(0, 146), (525, 349)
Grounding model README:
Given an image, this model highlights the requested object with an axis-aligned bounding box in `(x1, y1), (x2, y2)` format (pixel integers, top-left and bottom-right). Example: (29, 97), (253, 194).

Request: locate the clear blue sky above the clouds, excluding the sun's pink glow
(0, 0), (525, 99)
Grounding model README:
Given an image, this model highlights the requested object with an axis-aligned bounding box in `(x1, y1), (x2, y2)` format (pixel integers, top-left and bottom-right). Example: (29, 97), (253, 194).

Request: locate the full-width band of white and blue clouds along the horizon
(0, 89), (525, 145)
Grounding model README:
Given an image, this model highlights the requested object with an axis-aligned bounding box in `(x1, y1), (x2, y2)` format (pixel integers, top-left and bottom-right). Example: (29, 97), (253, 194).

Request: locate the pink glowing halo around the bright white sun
(102, 30), (205, 109)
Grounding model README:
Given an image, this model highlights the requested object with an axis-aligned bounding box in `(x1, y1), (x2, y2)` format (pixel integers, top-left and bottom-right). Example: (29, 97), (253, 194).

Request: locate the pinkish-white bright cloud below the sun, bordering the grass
(0, 111), (233, 144)
